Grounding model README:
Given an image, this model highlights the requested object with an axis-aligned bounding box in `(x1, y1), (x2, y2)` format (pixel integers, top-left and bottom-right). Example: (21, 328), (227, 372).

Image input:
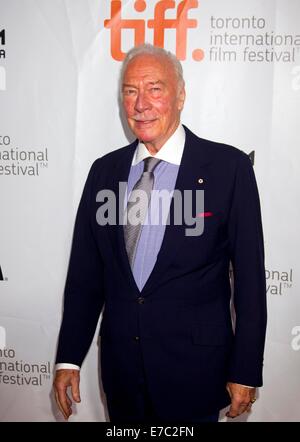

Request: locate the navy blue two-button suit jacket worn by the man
(57, 128), (266, 420)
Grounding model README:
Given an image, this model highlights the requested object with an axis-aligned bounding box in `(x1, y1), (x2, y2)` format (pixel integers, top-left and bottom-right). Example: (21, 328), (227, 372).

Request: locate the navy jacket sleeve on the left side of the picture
(56, 160), (104, 366)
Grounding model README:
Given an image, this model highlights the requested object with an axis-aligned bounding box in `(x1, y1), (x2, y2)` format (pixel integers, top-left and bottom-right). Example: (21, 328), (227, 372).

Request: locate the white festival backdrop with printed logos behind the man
(0, 0), (300, 421)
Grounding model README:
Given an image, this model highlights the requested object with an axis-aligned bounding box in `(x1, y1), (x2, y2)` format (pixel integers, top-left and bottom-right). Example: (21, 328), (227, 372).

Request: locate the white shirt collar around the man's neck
(131, 124), (185, 166)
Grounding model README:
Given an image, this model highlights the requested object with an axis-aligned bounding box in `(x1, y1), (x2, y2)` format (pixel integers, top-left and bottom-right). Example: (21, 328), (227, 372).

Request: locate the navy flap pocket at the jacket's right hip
(192, 323), (233, 346)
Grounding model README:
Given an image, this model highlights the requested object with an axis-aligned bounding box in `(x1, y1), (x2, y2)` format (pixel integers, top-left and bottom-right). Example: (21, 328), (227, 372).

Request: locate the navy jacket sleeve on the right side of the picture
(228, 154), (267, 387)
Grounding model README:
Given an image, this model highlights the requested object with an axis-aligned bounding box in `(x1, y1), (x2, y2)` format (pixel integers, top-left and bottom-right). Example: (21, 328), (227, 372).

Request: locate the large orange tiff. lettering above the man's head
(104, 0), (204, 61)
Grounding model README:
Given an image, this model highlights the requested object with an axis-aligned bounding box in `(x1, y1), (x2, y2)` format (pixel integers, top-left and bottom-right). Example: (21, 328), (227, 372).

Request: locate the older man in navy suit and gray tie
(54, 45), (266, 422)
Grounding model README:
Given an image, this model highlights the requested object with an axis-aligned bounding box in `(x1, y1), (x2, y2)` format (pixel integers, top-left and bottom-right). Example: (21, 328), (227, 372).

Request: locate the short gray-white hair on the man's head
(120, 43), (185, 92)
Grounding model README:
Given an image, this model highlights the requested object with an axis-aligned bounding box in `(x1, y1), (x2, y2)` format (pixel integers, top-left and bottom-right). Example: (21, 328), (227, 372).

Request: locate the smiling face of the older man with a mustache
(122, 54), (185, 153)
